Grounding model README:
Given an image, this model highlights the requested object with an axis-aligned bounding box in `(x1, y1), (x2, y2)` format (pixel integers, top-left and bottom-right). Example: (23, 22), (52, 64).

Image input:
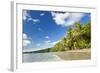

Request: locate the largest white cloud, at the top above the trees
(51, 12), (85, 26)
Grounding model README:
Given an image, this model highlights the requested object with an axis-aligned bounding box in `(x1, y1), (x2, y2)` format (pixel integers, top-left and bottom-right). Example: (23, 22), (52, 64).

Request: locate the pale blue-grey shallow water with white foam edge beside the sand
(23, 53), (61, 62)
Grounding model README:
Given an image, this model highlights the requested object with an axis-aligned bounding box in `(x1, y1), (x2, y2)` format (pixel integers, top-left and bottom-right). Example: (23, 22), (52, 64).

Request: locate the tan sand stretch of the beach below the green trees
(55, 49), (91, 60)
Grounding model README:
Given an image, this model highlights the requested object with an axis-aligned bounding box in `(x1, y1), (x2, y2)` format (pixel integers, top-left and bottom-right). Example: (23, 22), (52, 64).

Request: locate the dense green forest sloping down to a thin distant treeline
(23, 21), (91, 53)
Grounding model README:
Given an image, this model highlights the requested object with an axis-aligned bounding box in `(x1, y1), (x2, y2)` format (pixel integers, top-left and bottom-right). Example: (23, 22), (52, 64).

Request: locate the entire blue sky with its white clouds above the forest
(22, 10), (91, 51)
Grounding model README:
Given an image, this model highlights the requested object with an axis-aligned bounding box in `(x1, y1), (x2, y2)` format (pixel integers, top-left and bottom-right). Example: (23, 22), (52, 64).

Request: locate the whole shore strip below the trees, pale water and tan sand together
(23, 49), (91, 62)
